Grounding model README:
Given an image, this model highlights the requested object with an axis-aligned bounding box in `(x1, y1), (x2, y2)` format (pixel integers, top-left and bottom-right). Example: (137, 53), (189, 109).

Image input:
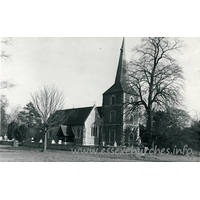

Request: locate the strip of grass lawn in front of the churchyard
(0, 145), (200, 162)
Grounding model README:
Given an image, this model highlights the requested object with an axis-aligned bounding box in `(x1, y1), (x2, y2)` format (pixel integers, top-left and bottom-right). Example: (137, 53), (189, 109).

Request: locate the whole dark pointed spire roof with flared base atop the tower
(104, 38), (127, 94)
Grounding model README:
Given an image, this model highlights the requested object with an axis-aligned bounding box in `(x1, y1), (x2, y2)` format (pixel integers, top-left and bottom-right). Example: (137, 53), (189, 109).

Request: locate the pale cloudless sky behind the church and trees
(1, 37), (200, 117)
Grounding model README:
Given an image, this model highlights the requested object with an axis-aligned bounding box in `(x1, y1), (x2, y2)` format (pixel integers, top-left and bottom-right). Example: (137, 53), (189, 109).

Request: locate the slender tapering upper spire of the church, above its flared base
(115, 38), (126, 84)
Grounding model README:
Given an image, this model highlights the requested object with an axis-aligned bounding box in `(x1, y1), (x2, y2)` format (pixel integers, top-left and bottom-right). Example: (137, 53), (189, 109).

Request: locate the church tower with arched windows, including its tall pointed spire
(102, 38), (137, 146)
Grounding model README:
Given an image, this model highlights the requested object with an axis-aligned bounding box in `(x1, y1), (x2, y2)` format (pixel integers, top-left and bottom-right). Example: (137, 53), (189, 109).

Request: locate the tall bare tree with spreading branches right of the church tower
(129, 37), (183, 146)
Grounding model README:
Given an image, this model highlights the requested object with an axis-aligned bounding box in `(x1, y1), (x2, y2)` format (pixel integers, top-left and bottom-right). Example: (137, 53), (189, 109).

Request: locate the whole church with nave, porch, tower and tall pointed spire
(48, 38), (139, 146)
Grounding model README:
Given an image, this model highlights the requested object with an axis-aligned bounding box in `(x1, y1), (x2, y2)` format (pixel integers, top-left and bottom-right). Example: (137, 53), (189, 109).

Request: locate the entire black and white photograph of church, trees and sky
(0, 37), (200, 162)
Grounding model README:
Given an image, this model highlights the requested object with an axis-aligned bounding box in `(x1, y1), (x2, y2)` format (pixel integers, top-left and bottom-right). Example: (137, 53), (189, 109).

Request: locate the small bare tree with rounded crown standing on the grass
(31, 85), (64, 152)
